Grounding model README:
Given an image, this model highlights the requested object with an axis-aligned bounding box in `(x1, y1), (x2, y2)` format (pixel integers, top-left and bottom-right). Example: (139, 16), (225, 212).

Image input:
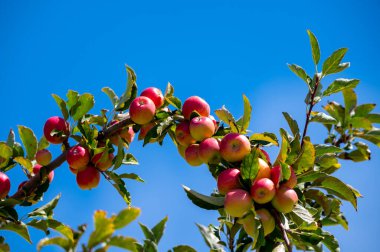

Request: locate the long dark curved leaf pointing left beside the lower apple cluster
(182, 185), (224, 210)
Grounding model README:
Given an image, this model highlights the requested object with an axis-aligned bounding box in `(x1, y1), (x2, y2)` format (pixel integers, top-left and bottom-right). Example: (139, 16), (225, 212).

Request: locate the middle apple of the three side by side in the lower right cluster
(251, 178), (276, 204)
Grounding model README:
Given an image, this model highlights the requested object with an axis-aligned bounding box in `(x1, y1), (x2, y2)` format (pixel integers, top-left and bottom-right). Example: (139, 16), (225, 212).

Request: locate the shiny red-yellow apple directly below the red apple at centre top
(189, 116), (215, 141)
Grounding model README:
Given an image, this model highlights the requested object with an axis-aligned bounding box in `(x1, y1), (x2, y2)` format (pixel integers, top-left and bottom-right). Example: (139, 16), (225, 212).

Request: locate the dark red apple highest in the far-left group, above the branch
(44, 116), (70, 144)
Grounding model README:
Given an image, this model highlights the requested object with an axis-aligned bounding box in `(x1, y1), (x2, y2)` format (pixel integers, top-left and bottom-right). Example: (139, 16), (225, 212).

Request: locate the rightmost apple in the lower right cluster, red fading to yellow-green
(272, 185), (298, 213)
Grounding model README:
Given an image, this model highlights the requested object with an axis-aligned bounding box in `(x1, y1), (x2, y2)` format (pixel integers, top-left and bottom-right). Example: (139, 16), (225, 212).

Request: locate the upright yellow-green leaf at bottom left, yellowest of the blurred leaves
(88, 210), (115, 249)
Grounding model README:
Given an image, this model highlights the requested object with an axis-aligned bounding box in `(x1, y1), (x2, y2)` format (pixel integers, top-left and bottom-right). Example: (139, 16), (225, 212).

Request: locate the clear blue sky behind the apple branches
(0, 0), (380, 251)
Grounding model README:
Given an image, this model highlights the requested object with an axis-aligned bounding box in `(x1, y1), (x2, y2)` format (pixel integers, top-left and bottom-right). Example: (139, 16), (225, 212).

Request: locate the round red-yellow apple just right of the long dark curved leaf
(224, 189), (253, 217)
